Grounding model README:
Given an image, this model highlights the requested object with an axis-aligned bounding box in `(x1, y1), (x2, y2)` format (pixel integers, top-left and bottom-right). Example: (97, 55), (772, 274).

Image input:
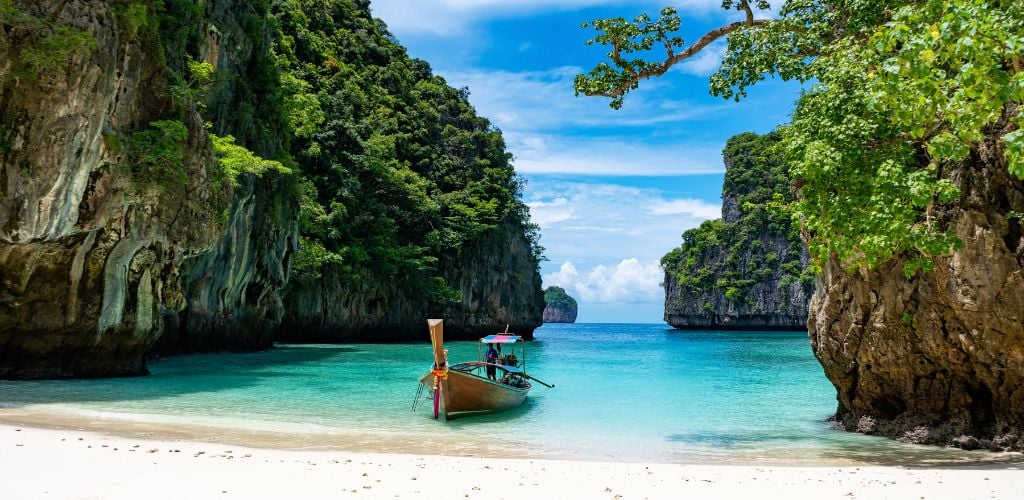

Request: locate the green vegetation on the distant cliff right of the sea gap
(662, 132), (813, 302)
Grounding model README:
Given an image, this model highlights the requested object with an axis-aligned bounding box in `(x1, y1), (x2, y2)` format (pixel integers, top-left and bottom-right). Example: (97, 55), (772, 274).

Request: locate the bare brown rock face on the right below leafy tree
(808, 116), (1024, 450)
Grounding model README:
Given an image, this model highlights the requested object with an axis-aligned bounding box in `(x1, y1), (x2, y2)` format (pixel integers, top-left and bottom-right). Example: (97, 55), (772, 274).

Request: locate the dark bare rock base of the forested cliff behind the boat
(280, 223), (544, 342)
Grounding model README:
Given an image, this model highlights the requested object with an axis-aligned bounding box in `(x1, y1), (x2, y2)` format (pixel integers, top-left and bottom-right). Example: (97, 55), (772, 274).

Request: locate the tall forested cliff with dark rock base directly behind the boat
(274, 0), (544, 341)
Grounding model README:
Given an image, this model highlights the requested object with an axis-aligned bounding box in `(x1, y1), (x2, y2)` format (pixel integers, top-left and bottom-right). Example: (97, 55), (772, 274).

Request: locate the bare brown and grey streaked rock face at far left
(0, 0), (295, 378)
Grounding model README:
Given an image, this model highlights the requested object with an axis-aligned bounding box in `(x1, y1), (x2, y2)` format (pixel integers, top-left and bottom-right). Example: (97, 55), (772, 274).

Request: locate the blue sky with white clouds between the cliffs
(372, 0), (799, 323)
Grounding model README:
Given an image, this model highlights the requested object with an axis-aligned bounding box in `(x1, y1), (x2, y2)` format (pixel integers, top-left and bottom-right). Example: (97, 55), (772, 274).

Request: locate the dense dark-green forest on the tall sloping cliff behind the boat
(271, 0), (536, 301)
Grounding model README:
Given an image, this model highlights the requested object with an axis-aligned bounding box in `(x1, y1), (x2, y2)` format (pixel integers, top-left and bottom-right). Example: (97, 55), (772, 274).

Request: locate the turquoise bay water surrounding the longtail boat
(0, 324), (1011, 464)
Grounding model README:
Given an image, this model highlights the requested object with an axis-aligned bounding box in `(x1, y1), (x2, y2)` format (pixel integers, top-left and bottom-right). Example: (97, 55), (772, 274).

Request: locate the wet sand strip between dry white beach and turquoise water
(8, 403), (1024, 468)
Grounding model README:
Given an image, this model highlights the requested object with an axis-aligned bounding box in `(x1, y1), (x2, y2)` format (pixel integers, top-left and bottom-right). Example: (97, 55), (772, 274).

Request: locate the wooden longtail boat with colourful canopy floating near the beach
(420, 320), (554, 419)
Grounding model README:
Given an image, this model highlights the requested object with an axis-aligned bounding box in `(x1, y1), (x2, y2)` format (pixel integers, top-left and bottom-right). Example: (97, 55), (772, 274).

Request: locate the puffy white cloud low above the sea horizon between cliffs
(544, 258), (663, 303)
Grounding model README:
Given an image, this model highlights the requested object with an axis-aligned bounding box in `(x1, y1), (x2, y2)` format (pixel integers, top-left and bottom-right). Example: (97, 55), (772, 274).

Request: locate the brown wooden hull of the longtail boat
(420, 370), (529, 418)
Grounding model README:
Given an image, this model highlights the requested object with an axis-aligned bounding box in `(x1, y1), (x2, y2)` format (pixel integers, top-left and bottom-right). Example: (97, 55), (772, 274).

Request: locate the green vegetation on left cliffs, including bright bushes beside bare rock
(139, 0), (540, 302)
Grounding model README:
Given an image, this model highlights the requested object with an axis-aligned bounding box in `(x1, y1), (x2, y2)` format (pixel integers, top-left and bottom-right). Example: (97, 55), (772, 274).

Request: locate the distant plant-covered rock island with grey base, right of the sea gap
(662, 133), (813, 330)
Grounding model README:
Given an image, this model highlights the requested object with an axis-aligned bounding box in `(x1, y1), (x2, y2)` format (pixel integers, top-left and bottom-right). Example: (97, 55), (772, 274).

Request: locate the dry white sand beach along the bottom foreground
(0, 424), (1024, 500)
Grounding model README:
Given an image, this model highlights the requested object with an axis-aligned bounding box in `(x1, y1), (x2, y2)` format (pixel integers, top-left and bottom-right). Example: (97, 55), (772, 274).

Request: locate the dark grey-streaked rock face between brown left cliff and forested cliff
(155, 176), (298, 353)
